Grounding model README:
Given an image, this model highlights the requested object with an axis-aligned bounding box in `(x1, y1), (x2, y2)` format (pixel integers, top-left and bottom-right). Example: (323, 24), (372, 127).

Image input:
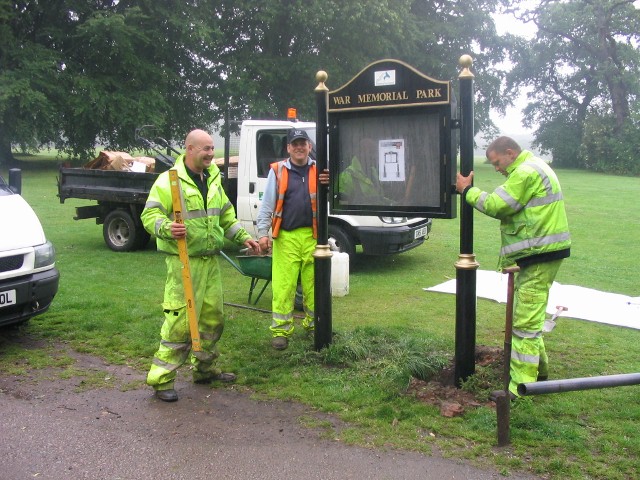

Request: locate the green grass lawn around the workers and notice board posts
(0, 157), (640, 479)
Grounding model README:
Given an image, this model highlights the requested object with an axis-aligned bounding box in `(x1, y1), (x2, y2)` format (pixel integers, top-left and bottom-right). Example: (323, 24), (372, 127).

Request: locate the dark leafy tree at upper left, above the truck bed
(0, 0), (225, 161)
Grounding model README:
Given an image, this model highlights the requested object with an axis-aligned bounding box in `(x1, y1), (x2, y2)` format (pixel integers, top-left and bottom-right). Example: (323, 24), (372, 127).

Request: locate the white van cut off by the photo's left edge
(0, 169), (60, 326)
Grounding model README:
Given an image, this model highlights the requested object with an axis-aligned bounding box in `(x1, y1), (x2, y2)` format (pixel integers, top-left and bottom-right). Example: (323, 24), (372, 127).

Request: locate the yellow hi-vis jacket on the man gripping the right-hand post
(466, 150), (571, 267)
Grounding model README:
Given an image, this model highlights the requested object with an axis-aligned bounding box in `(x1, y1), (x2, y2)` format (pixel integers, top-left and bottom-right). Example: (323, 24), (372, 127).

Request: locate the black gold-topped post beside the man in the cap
(313, 70), (332, 350)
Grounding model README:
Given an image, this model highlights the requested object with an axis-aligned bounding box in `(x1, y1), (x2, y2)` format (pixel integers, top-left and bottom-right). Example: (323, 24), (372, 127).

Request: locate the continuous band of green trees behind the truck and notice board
(0, 0), (505, 161)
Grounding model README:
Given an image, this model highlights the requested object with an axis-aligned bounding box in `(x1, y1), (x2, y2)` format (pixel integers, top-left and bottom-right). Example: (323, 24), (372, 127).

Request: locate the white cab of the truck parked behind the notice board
(228, 120), (431, 255)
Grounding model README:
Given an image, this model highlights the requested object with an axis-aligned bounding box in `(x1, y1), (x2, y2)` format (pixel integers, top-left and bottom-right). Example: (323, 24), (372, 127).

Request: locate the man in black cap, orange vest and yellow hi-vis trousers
(257, 128), (329, 350)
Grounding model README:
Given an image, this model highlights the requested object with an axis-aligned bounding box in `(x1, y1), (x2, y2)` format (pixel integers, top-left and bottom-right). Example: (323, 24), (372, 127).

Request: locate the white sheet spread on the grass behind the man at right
(423, 270), (640, 329)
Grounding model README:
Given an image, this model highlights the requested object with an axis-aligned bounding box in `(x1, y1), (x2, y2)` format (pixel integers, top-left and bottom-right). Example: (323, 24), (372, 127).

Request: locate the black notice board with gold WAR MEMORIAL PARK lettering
(327, 60), (457, 218)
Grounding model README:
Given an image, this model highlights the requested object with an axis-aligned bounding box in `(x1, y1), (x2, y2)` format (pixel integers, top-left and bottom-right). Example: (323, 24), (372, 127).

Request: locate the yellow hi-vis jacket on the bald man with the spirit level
(140, 155), (251, 256)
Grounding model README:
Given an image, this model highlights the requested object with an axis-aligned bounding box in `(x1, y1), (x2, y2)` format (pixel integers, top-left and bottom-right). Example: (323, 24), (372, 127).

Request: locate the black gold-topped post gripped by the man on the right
(454, 55), (480, 387)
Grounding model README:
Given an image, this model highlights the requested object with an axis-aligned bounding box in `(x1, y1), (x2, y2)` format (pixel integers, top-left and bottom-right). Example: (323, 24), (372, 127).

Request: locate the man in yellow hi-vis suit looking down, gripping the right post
(456, 137), (571, 400)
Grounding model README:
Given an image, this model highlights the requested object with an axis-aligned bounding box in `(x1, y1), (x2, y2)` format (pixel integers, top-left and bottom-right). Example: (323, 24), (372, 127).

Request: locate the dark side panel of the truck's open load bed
(58, 167), (158, 204)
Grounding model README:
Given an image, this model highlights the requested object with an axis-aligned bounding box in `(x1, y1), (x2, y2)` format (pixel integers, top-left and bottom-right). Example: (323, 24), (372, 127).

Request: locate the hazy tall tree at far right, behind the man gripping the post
(507, 0), (640, 167)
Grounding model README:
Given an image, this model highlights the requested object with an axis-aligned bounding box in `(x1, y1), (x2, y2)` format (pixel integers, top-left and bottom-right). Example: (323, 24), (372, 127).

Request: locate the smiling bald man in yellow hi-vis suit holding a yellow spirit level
(140, 130), (260, 402)
